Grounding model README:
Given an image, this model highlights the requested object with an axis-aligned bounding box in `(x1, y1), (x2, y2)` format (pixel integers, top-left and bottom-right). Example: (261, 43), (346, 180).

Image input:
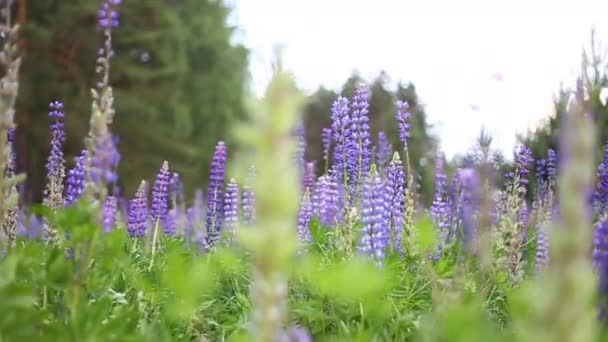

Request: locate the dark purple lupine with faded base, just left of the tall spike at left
(45, 101), (65, 210)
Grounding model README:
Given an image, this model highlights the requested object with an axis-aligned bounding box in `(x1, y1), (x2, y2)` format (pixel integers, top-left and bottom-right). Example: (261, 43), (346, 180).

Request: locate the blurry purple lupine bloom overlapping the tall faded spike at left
(90, 133), (120, 184)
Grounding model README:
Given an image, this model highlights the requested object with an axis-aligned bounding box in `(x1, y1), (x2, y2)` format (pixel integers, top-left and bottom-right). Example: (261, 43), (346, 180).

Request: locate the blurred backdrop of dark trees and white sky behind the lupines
(8, 0), (608, 206)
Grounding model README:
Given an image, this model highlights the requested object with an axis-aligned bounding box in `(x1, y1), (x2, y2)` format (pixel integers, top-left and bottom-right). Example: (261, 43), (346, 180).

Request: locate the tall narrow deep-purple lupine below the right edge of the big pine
(207, 141), (227, 246)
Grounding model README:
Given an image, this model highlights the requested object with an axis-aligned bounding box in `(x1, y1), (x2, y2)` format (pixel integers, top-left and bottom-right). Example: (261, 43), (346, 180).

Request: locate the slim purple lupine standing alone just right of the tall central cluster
(431, 157), (450, 255)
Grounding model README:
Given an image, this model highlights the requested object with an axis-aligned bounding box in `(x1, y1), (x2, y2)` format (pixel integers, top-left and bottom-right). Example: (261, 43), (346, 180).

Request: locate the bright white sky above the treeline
(229, 0), (608, 157)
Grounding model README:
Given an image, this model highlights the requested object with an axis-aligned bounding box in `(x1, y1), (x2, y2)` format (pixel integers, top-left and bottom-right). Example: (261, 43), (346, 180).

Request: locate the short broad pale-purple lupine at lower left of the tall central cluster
(312, 175), (342, 227)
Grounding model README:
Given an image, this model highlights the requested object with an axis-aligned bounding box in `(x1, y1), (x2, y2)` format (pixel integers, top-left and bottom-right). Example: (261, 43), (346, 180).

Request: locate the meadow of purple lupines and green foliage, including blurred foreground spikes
(0, 0), (608, 342)
